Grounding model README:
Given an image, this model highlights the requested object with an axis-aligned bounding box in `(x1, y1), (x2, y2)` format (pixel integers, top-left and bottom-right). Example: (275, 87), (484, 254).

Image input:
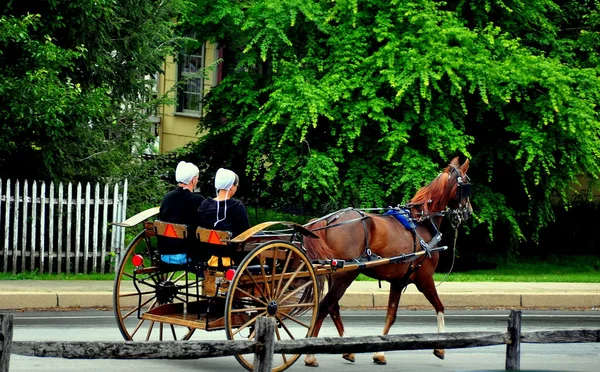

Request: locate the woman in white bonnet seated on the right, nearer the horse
(198, 168), (250, 236)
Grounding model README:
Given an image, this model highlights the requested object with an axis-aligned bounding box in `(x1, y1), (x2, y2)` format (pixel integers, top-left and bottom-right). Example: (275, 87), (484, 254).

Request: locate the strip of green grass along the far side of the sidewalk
(0, 256), (600, 283)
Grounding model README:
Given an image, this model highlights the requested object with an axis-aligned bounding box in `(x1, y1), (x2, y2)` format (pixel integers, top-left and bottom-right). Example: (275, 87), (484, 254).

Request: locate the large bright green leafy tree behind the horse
(184, 0), (600, 253)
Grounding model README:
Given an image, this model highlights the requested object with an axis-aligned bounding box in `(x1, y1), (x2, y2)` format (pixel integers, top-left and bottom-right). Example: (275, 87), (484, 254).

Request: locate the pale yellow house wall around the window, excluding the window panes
(158, 43), (218, 154)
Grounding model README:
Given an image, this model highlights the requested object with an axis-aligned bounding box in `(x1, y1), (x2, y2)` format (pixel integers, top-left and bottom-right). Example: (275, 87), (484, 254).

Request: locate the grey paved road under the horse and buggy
(5, 310), (600, 372)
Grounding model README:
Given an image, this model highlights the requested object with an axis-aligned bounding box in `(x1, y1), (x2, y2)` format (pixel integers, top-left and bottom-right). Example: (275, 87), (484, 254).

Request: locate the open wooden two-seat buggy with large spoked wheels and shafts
(113, 208), (446, 371)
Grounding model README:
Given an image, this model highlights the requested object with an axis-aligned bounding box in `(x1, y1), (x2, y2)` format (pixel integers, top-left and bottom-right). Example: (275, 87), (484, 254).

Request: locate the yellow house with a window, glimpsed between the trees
(154, 43), (221, 154)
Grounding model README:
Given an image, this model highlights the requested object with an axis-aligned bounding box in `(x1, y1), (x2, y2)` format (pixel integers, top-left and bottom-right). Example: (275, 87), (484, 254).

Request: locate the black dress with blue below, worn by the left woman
(158, 187), (204, 263)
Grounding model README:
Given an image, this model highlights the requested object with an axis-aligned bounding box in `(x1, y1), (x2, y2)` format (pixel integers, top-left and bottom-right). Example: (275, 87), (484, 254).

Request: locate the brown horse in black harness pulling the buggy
(304, 158), (472, 367)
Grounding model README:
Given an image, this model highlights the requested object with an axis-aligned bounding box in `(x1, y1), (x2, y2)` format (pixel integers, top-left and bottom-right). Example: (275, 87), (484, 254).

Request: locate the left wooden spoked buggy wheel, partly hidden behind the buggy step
(113, 231), (202, 341)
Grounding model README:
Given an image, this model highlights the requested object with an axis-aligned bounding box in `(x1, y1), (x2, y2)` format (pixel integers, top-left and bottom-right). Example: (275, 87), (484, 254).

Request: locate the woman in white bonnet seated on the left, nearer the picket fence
(158, 161), (204, 264)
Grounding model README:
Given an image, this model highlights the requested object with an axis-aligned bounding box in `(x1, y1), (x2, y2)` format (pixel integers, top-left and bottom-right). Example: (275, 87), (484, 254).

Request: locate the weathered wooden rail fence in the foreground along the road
(0, 310), (600, 372)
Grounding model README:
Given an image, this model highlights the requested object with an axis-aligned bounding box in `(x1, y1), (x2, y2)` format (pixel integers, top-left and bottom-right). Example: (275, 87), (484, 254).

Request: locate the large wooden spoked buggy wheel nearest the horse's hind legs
(225, 241), (321, 371)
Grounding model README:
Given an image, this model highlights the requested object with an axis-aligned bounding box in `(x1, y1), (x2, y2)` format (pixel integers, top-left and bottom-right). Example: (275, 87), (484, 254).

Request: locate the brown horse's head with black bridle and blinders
(444, 157), (473, 226)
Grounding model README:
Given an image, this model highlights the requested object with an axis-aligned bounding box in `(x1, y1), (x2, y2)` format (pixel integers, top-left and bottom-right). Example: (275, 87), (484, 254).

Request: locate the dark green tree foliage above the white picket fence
(0, 0), (185, 186)
